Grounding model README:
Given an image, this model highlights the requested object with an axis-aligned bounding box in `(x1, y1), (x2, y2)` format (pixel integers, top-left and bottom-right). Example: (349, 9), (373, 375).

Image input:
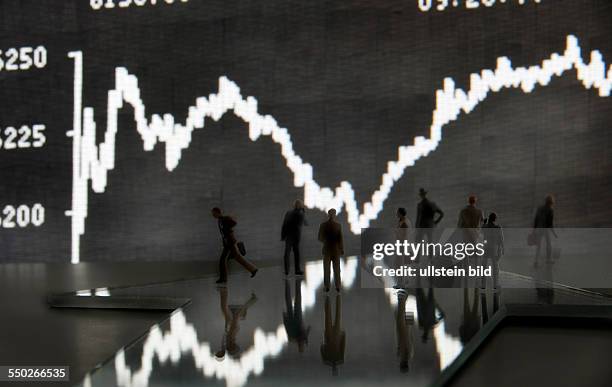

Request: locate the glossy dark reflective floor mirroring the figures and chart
(75, 258), (612, 387)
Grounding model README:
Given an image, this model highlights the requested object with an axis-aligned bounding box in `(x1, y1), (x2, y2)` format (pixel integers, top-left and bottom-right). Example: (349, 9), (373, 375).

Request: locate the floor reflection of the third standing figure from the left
(321, 294), (346, 376)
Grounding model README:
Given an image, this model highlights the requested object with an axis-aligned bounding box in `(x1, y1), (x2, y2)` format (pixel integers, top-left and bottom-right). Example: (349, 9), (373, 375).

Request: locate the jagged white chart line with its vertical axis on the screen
(67, 35), (612, 263)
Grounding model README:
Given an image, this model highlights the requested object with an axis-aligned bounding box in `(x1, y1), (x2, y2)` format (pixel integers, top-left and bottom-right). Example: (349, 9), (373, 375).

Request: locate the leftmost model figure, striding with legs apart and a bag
(211, 207), (257, 283)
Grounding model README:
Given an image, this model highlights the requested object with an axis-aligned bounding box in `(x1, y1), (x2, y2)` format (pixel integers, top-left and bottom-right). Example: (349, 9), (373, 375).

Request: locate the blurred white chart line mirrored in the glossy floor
(84, 257), (462, 387)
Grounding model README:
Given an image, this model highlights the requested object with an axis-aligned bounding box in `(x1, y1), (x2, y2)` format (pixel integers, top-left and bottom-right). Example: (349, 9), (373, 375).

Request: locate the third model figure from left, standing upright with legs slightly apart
(319, 208), (344, 292)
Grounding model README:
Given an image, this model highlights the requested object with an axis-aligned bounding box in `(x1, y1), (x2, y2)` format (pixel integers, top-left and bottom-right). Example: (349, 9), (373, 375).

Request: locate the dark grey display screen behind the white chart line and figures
(0, 0), (612, 262)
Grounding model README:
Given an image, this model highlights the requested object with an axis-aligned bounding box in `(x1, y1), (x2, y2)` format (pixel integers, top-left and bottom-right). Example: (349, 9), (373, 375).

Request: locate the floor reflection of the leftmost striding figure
(215, 287), (257, 360)
